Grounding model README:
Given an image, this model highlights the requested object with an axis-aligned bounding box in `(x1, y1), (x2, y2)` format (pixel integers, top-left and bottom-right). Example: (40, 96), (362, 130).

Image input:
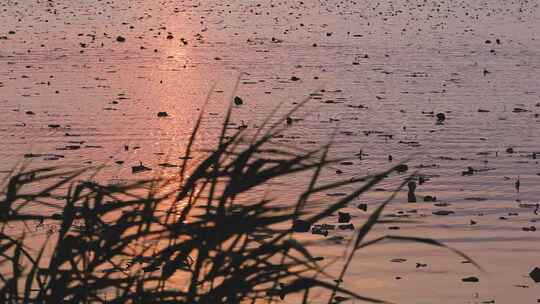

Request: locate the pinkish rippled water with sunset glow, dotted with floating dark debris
(0, 0), (540, 303)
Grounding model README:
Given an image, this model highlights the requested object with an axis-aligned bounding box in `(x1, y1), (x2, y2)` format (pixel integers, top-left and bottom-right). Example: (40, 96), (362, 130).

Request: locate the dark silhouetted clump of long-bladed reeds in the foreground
(0, 100), (476, 304)
